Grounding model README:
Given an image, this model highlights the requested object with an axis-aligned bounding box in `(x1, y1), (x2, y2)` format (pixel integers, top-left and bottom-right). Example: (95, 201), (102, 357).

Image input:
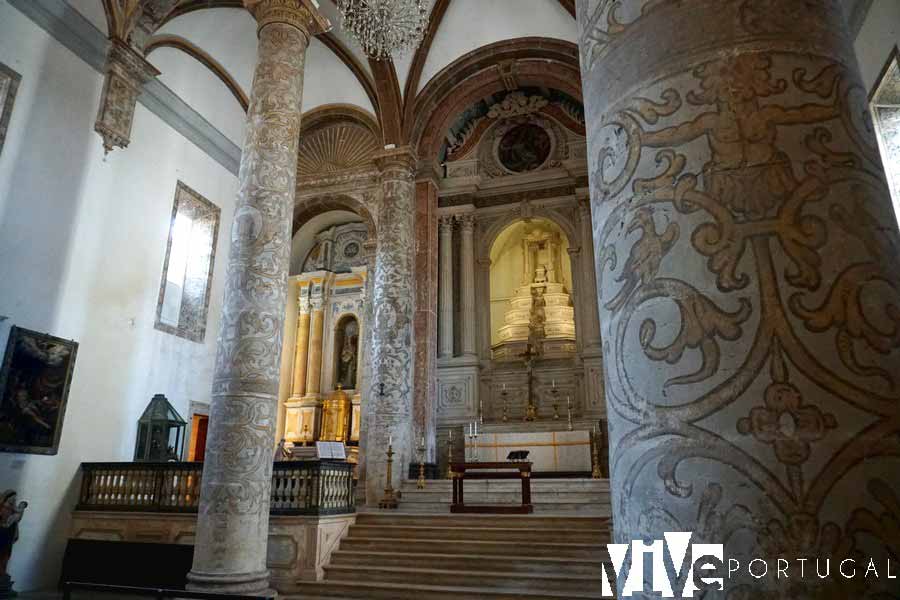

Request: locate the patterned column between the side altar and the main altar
(366, 148), (416, 500)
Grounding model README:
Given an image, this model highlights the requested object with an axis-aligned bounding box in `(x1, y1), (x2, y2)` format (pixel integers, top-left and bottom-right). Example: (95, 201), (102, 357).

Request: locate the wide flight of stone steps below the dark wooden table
(288, 512), (610, 600)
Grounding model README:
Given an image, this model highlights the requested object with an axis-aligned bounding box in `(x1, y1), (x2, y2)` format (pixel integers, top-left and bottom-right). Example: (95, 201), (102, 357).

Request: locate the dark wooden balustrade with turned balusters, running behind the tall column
(76, 461), (356, 515)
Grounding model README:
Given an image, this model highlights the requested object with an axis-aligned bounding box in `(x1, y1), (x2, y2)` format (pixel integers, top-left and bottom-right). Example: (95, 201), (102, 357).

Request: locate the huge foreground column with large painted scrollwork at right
(579, 0), (900, 598)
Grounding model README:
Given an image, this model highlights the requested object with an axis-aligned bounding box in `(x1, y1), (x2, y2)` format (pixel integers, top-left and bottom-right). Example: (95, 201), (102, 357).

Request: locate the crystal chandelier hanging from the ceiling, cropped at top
(335, 0), (429, 60)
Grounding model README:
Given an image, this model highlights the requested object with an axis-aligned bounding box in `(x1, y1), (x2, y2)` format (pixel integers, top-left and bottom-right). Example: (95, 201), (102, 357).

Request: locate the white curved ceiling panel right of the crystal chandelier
(416, 0), (576, 91)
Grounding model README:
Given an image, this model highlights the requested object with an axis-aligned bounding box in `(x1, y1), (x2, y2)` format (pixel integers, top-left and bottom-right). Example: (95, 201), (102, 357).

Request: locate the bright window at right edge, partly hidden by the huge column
(871, 48), (900, 226)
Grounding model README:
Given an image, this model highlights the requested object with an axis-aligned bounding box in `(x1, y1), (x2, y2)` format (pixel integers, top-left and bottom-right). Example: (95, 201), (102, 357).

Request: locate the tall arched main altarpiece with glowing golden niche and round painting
(437, 88), (605, 429)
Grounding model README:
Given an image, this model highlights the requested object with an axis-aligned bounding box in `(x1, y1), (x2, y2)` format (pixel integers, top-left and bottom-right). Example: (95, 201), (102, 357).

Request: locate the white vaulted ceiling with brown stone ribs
(81, 0), (577, 152)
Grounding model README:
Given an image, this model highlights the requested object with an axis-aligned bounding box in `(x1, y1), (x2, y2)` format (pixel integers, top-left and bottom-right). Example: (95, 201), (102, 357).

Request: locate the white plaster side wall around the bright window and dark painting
(0, 0), (237, 590)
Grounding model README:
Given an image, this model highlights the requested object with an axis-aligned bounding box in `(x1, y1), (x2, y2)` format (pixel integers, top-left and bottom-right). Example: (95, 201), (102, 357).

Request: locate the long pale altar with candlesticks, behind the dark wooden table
(466, 427), (591, 473)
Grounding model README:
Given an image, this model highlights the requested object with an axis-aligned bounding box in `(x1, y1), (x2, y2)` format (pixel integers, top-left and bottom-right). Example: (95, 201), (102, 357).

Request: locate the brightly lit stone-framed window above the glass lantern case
(156, 181), (219, 342)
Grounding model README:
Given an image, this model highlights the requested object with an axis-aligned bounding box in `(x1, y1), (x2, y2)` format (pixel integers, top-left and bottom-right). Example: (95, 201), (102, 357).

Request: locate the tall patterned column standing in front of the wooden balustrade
(188, 0), (328, 594)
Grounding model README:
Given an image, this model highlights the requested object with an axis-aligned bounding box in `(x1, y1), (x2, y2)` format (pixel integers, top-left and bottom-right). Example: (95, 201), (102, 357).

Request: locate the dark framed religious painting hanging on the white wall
(0, 327), (78, 454)
